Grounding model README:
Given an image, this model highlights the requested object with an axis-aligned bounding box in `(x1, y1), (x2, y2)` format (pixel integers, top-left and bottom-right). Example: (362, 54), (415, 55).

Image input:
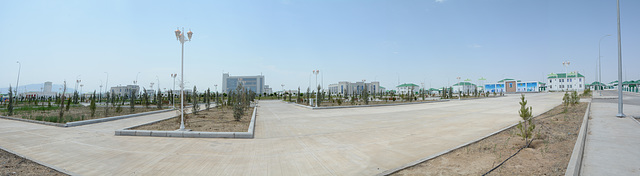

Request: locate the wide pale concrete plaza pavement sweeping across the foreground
(0, 93), (562, 175)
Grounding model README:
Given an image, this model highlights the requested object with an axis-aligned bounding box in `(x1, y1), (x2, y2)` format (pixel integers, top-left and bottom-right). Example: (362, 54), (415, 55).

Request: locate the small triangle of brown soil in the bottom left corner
(0, 150), (67, 175)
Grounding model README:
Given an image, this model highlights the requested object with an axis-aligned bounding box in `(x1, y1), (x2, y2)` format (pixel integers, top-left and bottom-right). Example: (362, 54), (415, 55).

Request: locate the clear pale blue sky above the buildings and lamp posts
(0, 0), (640, 93)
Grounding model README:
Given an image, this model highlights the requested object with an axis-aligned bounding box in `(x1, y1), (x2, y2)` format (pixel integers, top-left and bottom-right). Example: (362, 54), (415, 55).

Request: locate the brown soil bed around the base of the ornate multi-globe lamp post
(133, 107), (251, 132)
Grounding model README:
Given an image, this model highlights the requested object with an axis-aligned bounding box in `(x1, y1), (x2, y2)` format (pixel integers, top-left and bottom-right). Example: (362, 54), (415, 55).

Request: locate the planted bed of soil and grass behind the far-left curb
(5, 105), (165, 123)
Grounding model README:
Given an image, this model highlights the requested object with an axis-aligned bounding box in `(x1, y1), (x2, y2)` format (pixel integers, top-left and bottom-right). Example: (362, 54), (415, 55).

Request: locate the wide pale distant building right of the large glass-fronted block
(328, 81), (385, 95)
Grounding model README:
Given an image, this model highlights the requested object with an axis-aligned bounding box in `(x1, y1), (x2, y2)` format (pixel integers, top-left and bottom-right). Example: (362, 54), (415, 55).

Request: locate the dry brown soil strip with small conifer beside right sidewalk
(394, 103), (588, 175)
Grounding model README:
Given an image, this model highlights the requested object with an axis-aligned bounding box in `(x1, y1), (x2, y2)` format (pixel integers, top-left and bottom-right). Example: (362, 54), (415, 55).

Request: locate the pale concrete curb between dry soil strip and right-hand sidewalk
(564, 102), (591, 176)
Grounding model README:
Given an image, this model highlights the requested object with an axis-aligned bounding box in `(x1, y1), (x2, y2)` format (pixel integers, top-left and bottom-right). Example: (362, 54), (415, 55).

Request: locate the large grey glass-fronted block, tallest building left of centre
(222, 73), (265, 94)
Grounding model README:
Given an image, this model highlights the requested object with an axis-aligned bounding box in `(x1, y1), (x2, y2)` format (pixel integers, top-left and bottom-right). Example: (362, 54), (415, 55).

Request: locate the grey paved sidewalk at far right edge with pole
(581, 91), (640, 175)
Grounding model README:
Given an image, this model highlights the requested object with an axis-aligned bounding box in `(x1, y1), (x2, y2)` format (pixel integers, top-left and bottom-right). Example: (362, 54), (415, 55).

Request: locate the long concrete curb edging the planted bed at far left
(0, 109), (173, 127)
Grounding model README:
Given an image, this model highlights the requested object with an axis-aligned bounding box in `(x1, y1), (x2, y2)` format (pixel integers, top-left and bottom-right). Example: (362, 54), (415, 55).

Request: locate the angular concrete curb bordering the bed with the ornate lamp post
(115, 105), (258, 139)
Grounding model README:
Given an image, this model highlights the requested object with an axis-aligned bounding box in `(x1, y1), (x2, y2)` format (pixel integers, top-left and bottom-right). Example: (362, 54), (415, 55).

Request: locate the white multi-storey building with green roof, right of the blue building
(547, 72), (586, 91)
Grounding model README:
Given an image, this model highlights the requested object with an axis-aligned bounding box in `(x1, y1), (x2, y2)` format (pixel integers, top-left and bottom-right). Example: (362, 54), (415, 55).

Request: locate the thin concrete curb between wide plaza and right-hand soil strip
(376, 101), (553, 176)
